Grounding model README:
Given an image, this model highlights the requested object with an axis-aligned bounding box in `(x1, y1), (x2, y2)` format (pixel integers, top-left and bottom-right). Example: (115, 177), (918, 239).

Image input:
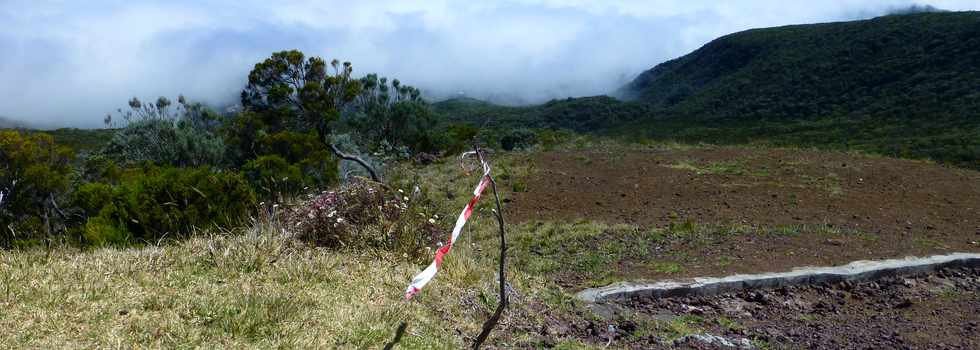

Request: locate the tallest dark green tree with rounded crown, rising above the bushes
(235, 50), (377, 185)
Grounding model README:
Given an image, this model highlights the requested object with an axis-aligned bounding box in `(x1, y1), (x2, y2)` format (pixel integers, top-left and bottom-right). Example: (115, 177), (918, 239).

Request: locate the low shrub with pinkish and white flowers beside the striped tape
(287, 178), (443, 258)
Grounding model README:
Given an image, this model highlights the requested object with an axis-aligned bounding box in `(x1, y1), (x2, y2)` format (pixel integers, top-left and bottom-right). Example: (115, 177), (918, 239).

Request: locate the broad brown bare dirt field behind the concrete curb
(508, 147), (980, 286)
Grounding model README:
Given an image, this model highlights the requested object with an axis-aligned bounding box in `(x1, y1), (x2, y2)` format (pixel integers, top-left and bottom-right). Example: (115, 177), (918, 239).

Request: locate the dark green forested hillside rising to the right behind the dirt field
(435, 12), (980, 168)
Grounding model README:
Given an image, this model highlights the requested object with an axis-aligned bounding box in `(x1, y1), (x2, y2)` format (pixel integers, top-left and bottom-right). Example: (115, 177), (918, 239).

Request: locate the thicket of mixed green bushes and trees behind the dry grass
(0, 50), (456, 252)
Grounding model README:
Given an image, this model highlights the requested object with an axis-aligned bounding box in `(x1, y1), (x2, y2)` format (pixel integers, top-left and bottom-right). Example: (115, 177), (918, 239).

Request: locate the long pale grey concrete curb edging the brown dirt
(576, 253), (980, 303)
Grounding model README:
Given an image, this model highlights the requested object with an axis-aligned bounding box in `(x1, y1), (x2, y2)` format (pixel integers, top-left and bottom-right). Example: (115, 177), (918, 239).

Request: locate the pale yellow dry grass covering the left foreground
(0, 150), (568, 349)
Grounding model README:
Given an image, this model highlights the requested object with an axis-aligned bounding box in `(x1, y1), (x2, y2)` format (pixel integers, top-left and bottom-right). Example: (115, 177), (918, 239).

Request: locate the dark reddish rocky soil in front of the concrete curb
(492, 268), (980, 349)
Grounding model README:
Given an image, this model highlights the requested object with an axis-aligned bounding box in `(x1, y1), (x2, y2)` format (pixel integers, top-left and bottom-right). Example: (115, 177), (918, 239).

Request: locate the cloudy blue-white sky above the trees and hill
(0, 0), (980, 127)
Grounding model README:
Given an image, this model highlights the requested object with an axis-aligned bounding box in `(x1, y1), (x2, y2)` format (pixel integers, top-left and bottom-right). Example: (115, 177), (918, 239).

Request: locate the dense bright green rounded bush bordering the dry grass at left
(82, 168), (256, 244)
